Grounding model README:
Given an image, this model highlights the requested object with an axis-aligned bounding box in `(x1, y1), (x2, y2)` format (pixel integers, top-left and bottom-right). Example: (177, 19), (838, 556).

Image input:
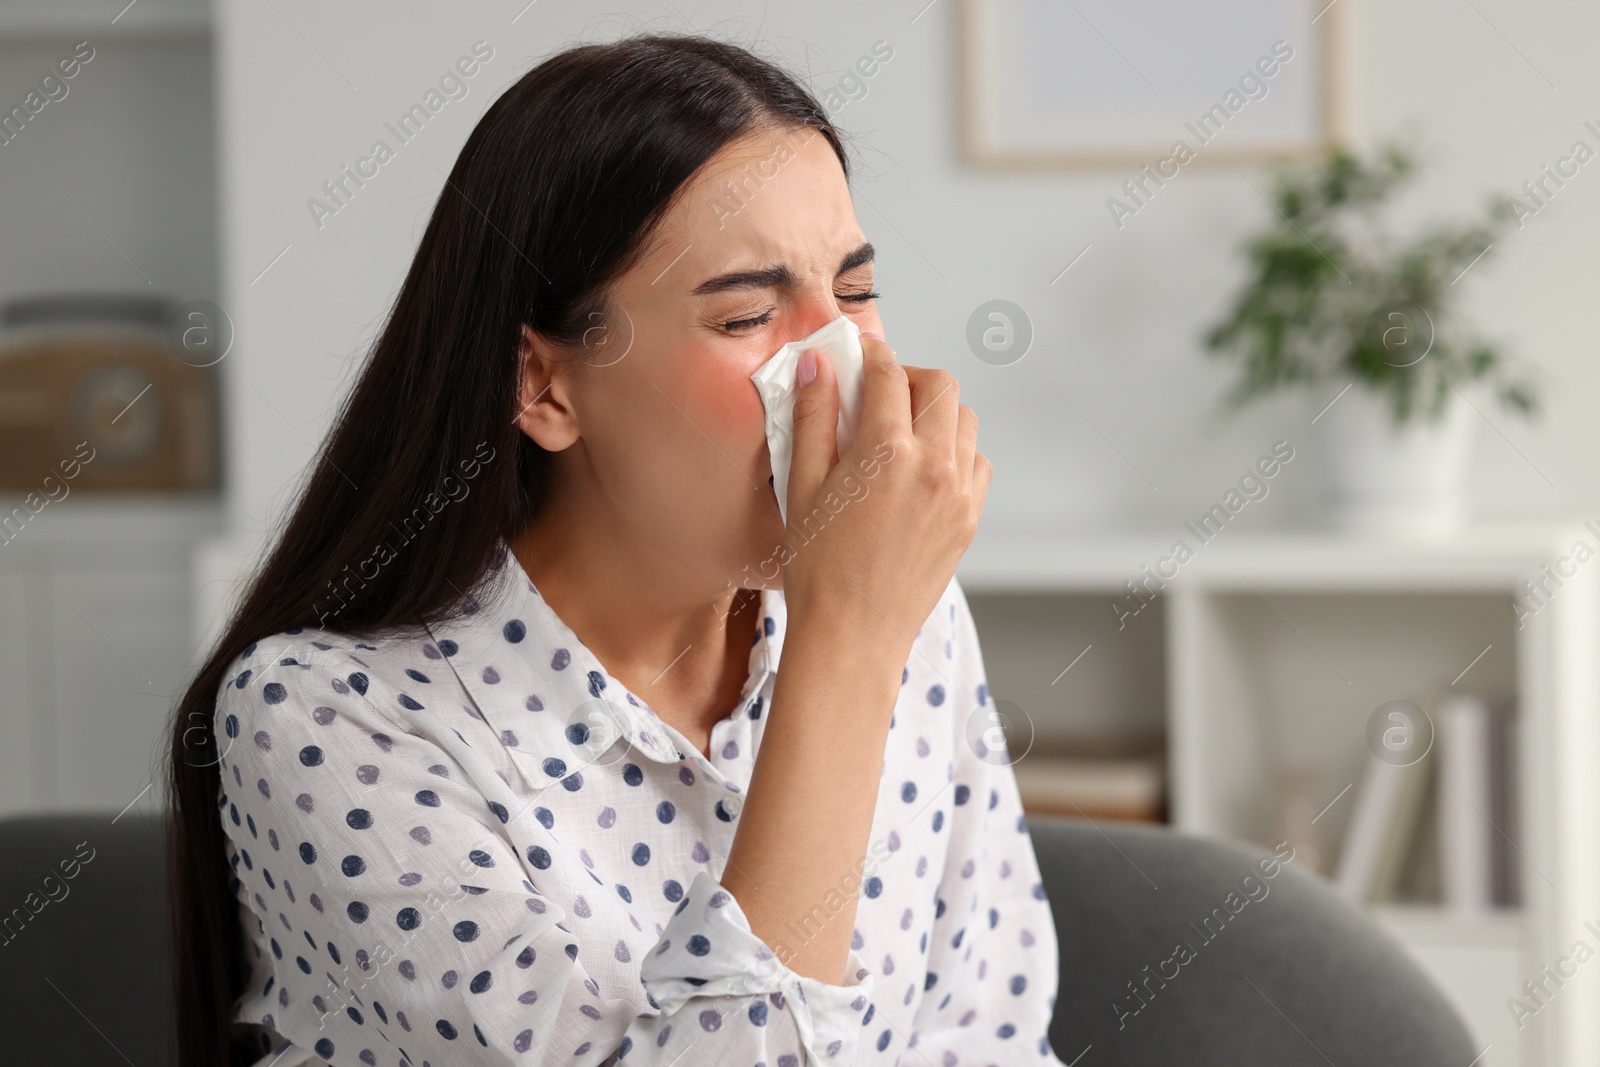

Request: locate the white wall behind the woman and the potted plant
(202, 0), (1600, 639)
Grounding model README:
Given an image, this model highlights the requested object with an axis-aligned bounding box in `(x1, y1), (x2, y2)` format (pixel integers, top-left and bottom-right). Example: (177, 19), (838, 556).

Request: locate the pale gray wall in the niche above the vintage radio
(0, 8), (218, 301)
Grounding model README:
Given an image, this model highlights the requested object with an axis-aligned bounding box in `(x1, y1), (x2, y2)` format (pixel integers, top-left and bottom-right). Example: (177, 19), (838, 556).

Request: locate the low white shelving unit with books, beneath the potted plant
(958, 522), (1600, 1067)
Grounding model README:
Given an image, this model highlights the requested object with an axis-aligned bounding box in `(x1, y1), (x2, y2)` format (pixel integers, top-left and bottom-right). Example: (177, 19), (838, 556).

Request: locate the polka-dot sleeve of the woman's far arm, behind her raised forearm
(915, 581), (1059, 1067)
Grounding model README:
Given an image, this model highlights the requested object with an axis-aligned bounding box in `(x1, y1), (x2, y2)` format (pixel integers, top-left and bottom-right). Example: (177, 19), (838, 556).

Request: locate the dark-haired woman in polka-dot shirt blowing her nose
(171, 37), (1056, 1067)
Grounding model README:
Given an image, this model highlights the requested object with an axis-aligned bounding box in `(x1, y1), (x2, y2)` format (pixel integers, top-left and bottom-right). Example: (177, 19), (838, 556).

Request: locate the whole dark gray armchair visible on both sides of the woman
(0, 813), (1477, 1067)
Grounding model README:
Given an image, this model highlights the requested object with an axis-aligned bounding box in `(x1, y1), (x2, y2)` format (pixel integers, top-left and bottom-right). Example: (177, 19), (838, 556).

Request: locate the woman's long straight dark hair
(166, 34), (850, 1067)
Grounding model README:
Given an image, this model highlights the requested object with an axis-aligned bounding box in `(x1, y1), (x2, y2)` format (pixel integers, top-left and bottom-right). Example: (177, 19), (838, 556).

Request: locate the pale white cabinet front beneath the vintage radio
(0, 494), (219, 816)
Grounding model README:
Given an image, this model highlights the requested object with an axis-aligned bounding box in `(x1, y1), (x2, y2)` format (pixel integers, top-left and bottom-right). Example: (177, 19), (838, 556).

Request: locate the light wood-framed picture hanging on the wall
(958, 0), (1344, 168)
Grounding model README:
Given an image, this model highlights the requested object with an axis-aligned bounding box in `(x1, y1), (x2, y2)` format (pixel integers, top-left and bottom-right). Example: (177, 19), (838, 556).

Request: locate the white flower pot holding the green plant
(1312, 384), (1480, 539)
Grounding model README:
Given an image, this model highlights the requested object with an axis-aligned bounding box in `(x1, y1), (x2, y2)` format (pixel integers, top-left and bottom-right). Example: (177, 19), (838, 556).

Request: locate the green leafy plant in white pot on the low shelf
(1205, 142), (1538, 536)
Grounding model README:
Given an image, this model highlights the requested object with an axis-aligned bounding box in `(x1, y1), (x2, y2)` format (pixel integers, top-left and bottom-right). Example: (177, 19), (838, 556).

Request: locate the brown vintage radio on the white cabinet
(0, 296), (220, 491)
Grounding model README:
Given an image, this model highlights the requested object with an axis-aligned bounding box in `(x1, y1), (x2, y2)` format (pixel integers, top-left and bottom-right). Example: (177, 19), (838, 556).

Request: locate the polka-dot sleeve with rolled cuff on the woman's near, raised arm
(216, 649), (872, 1067)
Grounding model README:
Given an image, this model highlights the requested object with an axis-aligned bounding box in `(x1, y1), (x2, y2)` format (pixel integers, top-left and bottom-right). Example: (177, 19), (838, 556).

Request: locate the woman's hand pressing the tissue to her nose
(784, 334), (994, 673)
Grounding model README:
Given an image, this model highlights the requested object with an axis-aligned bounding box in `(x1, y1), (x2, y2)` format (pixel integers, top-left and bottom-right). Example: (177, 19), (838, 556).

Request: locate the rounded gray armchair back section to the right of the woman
(1029, 817), (1480, 1067)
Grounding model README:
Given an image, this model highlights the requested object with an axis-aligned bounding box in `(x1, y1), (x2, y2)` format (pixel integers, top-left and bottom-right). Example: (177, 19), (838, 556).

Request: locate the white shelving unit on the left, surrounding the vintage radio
(0, 0), (219, 816)
